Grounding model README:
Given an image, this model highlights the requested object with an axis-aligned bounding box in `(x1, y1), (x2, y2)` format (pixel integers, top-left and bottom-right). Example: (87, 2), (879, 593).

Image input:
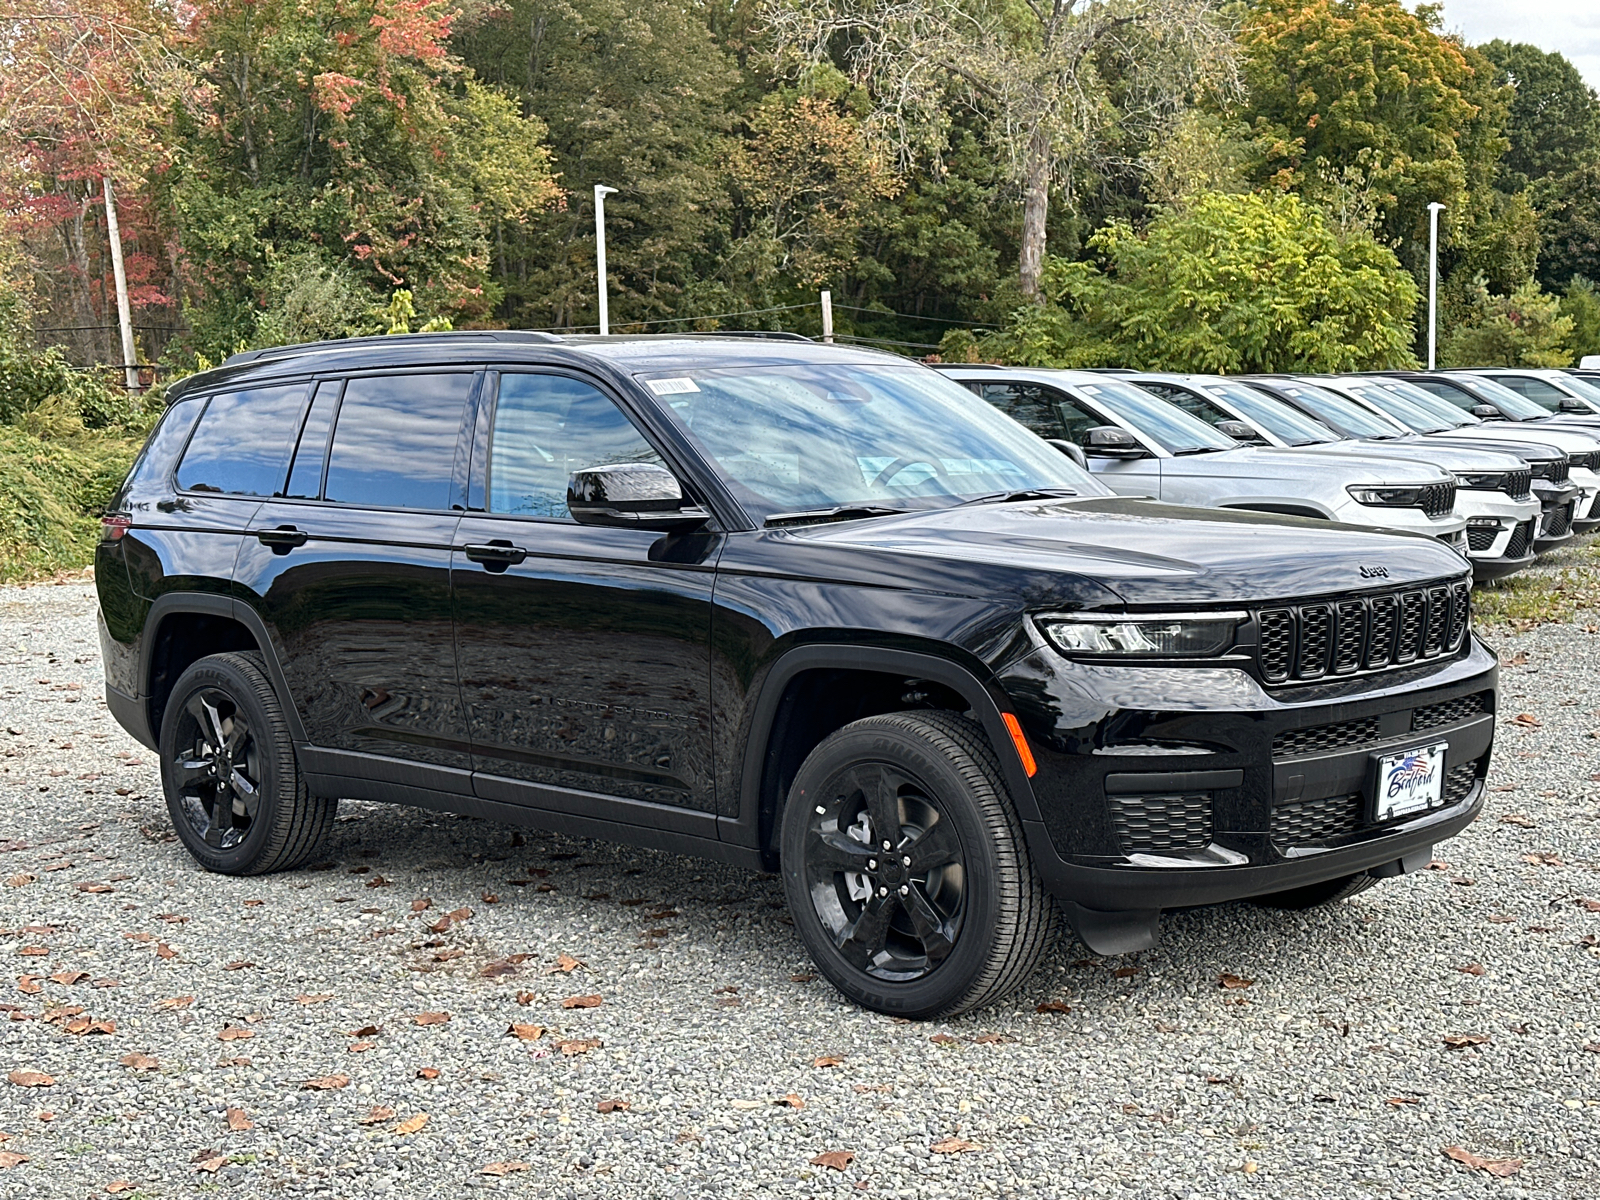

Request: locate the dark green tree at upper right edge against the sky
(1478, 40), (1600, 192)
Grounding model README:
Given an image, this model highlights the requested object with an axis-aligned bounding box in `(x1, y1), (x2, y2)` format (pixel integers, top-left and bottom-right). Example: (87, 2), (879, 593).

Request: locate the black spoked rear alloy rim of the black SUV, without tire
(173, 688), (261, 850)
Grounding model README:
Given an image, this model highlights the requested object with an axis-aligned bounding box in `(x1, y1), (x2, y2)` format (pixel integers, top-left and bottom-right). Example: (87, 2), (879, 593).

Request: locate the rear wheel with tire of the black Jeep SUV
(160, 653), (339, 875)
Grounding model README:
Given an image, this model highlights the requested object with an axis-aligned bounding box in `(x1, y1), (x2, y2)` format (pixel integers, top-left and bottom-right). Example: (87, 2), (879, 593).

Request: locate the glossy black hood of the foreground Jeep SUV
(780, 496), (1467, 608)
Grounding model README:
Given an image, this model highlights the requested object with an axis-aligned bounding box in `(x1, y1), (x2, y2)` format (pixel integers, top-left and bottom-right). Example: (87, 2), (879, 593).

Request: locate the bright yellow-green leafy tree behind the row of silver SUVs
(979, 192), (1418, 374)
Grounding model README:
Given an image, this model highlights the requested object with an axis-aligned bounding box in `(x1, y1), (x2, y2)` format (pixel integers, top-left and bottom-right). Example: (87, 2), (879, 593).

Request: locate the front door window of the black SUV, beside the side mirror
(490, 374), (661, 517)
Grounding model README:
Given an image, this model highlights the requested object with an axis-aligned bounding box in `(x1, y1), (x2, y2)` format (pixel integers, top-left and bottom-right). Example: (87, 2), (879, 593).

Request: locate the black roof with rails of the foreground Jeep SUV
(166, 330), (909, 403)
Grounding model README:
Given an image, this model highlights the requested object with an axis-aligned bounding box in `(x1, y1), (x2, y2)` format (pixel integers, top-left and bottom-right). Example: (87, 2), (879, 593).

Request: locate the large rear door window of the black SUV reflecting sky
(325, 374), (472, 509)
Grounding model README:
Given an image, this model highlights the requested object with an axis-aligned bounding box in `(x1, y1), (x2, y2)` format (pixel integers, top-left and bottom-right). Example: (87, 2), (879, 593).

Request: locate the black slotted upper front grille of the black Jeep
(1256, 582), (1469, 683)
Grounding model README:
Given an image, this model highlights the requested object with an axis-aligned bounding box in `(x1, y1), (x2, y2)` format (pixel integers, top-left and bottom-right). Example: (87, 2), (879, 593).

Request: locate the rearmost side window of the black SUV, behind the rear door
(178, 384), (306, 496)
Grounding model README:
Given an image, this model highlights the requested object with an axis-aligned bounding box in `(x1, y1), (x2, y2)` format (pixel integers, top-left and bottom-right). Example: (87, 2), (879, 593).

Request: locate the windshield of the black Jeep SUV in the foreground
(640, 363), (1109, 517)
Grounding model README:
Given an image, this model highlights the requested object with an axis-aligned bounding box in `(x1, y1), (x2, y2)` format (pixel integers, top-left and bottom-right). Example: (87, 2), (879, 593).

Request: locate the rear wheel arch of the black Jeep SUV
(139, 592), (306, 742)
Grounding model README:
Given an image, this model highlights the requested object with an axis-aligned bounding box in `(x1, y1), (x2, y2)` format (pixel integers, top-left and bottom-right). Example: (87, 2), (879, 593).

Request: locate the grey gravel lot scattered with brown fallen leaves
(0, 581), (1600, 1200)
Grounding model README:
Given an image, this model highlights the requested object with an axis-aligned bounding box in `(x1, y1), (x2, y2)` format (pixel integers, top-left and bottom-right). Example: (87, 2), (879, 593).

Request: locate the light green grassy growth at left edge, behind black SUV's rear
(0, 424), (141, 584)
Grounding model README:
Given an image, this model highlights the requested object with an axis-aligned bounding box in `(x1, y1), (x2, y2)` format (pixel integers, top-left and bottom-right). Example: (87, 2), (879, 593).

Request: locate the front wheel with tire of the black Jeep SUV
(779, 712), (1056, 1019)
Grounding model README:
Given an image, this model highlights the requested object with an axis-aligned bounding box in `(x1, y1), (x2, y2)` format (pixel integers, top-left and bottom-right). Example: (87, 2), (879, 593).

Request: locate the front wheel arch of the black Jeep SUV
(723, 645), (1038, 866)
